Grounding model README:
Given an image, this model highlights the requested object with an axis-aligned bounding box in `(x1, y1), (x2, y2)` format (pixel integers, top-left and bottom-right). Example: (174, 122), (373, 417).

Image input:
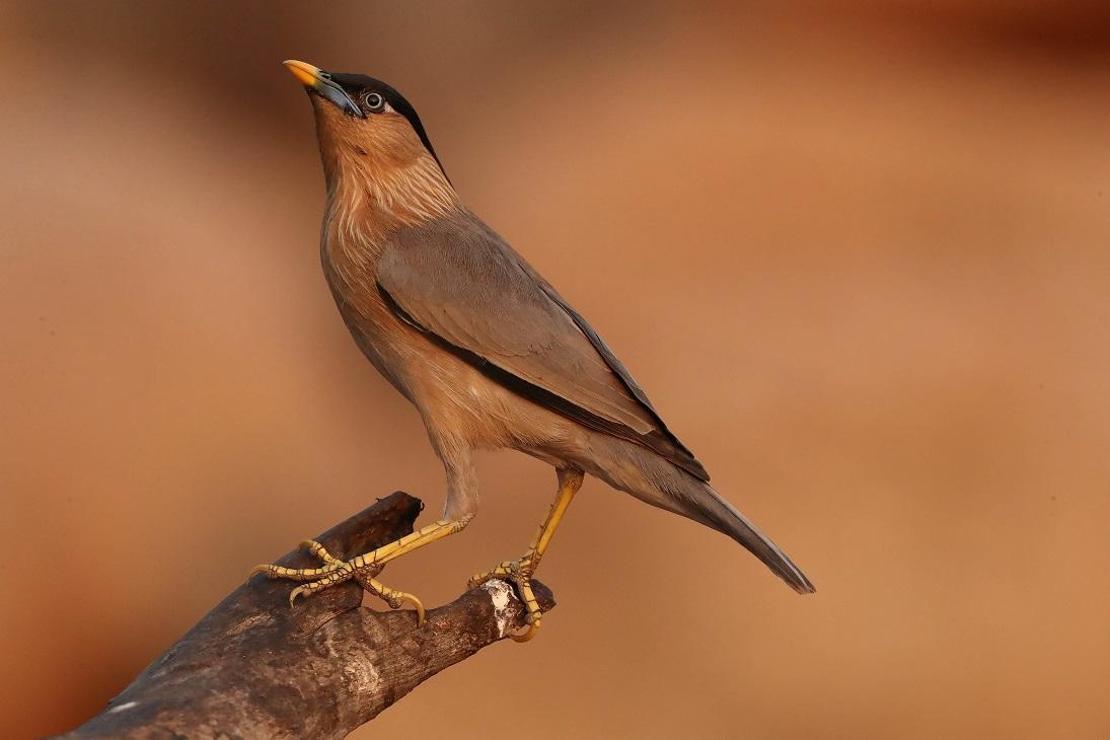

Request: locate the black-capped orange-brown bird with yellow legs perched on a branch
(259, 60), (815, 642)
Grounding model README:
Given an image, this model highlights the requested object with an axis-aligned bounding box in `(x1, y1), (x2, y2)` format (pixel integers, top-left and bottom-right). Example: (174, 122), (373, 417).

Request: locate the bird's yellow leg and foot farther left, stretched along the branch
(251, 519), (468, 622)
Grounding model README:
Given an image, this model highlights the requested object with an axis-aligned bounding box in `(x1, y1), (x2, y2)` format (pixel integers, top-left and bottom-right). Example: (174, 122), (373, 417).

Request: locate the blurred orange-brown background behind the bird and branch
(0, 0), (1110, 738)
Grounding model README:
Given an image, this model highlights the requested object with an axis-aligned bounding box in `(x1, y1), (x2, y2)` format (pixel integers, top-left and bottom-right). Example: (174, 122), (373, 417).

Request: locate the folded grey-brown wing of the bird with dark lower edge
(377, 212), (709, 480)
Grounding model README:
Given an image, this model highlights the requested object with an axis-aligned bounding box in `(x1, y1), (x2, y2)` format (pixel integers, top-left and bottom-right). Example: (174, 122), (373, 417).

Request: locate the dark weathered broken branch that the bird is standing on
(62, 491), (555, 738)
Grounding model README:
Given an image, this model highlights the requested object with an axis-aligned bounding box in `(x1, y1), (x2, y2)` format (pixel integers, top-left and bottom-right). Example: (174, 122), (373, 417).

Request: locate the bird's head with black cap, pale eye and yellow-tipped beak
(284, 60), (454, 219)
